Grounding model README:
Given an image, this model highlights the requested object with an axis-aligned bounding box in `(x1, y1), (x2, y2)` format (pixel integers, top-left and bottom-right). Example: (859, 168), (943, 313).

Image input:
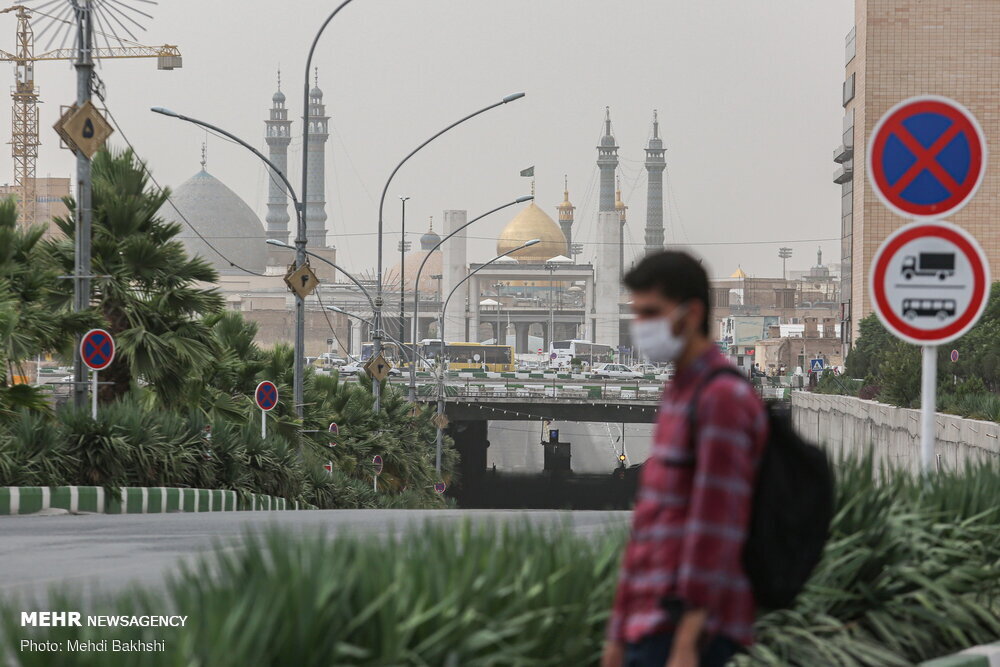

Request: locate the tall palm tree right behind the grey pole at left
(51, 150), (223, 406)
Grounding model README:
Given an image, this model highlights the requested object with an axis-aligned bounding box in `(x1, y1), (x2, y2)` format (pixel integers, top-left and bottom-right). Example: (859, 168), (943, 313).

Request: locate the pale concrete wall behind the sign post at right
(792, 391), (1000, 472)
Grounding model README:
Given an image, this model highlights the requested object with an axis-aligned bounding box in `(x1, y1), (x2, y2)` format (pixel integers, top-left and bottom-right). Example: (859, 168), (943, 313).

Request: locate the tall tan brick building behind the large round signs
(833, 0), (1000, 346)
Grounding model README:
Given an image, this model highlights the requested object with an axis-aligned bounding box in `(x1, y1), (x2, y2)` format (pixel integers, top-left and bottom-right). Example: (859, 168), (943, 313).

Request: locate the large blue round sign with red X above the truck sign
(867, 95), (986, 220)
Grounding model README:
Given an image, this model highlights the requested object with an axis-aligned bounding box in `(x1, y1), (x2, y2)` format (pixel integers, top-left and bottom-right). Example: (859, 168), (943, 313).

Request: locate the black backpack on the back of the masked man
(688, 367), (834, 609)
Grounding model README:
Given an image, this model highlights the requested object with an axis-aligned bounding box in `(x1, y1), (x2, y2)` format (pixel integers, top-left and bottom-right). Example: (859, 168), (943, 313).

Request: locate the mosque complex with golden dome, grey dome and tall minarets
(160, 74), (688, 356)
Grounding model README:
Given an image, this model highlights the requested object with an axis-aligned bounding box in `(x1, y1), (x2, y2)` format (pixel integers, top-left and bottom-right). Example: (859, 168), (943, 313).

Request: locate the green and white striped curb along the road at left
(0, 486), (313, 515)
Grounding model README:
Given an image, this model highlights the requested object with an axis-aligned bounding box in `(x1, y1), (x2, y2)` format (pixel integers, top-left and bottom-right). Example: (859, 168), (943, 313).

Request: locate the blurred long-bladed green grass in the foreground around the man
(0, 459), (1000, 667)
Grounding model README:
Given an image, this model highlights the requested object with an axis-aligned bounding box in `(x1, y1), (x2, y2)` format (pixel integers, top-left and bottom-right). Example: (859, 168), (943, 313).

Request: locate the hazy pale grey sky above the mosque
(11, 0), (854, 276)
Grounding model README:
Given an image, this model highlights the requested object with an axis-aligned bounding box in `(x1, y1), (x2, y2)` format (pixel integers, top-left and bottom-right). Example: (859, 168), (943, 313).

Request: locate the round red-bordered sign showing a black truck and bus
(869, 221), (990, 345)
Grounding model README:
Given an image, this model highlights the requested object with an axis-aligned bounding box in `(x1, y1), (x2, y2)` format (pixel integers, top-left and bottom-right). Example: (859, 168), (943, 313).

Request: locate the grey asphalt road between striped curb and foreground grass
(0, 510), (629, 597)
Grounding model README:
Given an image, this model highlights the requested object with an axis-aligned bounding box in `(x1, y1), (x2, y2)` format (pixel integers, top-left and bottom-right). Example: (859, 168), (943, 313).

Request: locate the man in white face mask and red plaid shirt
(602, 252), (767, 667)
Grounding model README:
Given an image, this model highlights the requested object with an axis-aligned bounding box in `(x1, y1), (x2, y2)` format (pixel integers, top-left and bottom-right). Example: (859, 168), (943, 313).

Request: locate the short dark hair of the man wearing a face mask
(625, 250), (710, 336)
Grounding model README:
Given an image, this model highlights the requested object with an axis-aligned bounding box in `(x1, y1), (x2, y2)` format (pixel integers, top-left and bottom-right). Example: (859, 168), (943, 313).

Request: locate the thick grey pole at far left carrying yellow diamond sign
(73, 0), (94, 408)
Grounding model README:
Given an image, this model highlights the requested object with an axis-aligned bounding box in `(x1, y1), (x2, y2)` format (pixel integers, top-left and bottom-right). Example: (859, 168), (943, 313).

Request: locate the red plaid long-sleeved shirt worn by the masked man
(608, 345), (767, 645)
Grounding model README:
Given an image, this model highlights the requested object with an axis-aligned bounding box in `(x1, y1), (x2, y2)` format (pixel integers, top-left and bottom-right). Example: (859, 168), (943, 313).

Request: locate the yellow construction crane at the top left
(0, 5), (183, 224)
